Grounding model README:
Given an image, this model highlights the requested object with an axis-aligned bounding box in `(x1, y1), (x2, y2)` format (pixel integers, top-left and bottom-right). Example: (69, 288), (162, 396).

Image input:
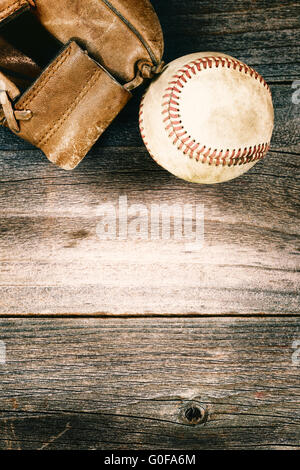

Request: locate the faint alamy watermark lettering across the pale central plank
(96, 196), (204, 251)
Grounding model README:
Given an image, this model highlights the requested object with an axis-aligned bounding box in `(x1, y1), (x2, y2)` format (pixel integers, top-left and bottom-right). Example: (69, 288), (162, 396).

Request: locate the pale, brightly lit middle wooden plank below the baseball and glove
(0, 143), (299, 314)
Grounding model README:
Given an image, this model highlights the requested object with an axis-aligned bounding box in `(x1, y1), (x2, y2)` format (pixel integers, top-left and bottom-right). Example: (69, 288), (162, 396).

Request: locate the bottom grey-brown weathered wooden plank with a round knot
(0, 318), (300, 450)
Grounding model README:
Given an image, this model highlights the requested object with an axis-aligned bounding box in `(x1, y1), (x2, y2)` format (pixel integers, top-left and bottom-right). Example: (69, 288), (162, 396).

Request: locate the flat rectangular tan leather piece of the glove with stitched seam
(11, 42), (131, 170)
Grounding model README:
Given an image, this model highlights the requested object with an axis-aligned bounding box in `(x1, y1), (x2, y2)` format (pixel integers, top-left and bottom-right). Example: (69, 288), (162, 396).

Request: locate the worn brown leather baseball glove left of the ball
(0, 0), (163, 170)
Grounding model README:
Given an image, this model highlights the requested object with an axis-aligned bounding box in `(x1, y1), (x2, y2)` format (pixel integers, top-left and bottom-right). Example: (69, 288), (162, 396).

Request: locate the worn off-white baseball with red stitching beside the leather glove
(140, 52), (274, 184)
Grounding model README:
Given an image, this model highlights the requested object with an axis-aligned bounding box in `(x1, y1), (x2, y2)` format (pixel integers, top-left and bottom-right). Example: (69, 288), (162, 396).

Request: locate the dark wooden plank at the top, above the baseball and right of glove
(153, 0), (300, 81)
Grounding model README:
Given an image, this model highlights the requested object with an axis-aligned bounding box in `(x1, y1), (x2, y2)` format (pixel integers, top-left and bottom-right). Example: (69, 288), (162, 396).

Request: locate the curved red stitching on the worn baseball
(158, 57), (271, 167)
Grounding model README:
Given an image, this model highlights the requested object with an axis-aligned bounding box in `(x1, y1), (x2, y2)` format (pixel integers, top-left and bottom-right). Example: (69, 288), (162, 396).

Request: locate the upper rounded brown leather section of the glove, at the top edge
(33, 0), (164, 82)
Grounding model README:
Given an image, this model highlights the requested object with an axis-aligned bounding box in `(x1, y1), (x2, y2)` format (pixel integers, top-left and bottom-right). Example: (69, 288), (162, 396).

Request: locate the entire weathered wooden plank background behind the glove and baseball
(0, 0), (300, 450)
